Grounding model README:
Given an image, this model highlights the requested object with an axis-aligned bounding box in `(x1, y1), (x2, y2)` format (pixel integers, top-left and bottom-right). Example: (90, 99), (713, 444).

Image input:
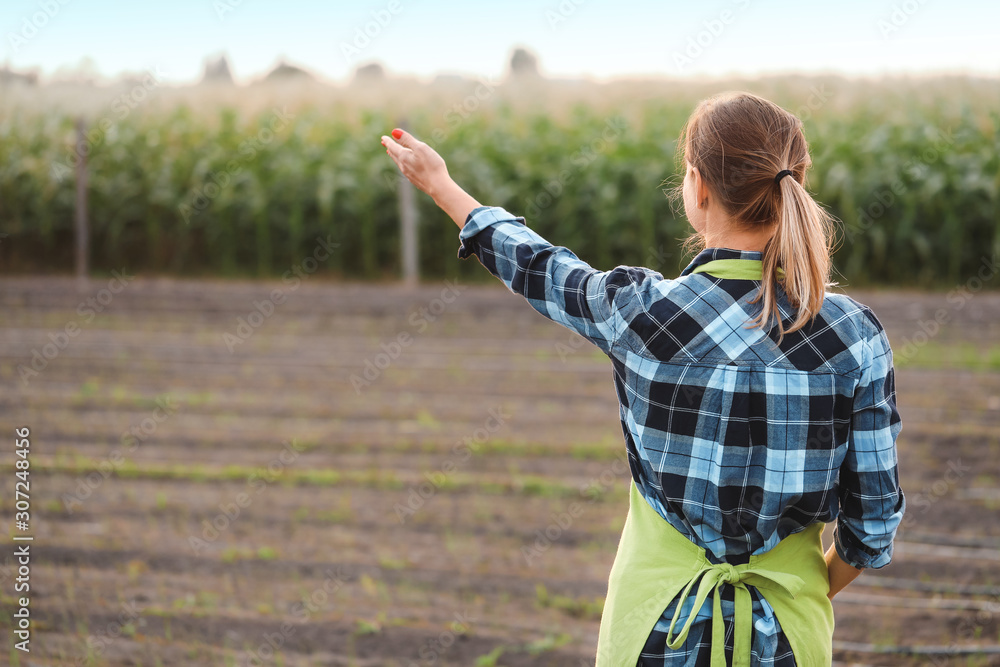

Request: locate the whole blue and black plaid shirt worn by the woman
(458, 206), (905, 666)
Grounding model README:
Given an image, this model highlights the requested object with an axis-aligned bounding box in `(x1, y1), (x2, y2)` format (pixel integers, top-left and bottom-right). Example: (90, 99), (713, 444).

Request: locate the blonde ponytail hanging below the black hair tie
(751, 170), (834, 341)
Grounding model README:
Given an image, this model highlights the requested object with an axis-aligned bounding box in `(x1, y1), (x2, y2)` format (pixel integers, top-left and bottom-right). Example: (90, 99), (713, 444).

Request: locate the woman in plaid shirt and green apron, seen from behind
(382, 93), (905, 667)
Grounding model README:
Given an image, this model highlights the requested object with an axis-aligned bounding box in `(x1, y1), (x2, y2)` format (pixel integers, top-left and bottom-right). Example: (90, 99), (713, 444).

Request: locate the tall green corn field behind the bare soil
(0, 77), (1000, 287)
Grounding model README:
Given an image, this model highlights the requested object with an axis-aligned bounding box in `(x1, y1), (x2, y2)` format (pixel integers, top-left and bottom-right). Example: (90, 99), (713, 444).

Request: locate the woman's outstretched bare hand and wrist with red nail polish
(382, 128), (480, 228)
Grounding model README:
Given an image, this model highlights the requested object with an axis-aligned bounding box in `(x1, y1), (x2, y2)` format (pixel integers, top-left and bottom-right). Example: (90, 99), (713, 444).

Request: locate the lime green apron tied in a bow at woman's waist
(597, 481), (833, 667)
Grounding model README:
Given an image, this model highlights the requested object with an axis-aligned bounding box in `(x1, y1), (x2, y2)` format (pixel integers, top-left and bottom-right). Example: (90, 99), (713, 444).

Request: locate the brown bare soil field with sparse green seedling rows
(0, 277), (1000, 667)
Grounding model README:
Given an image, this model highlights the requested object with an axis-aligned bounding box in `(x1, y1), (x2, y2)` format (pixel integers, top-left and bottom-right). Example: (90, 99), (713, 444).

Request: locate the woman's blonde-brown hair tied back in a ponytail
(673, 92), (835, 341)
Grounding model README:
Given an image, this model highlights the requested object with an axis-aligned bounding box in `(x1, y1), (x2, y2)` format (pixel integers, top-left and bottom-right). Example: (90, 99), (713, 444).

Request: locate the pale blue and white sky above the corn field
(0, 0), (1000, 83)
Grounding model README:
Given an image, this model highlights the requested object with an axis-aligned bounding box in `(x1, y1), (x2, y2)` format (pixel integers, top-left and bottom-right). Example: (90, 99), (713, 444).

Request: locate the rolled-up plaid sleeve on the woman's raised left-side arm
(458, 206), (663, 354)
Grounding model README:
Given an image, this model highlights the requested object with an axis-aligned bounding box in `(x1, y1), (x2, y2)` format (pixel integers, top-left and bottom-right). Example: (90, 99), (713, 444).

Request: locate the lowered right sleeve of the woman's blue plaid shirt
(834, 311), (906, 569)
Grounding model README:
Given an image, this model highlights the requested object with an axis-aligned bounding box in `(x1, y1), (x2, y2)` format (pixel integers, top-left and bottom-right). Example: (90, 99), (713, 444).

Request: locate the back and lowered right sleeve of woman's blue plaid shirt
(610, 249), (901, 567)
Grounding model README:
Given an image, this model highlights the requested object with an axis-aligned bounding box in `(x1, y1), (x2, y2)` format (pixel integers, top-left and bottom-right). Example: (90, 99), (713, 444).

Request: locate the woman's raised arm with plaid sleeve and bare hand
(382, 130), (663, 353)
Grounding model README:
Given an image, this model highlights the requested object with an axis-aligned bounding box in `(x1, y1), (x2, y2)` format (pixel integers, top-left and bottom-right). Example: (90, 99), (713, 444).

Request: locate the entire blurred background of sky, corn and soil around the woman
(0, 0), (1000, 667)
